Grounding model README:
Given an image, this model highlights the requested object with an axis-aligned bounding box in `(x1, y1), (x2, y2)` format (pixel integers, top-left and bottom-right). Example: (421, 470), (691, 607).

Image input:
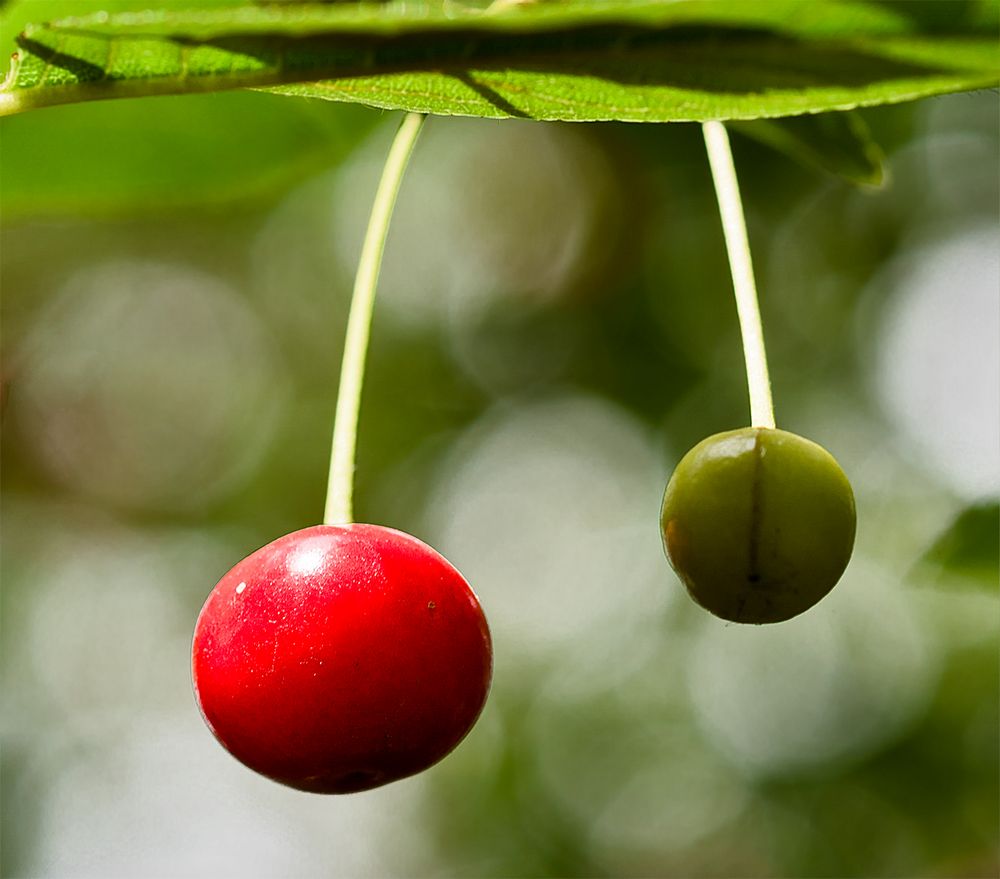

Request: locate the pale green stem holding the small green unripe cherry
(702, 122), (774, 428)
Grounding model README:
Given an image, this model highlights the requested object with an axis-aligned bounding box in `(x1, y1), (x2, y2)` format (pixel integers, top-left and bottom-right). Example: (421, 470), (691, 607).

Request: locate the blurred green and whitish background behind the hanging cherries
(0, 17), (1000, 879)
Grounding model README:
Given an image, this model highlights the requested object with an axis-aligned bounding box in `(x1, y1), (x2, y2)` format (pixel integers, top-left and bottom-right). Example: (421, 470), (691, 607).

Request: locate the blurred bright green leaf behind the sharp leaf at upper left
(0, 0), (377, 223)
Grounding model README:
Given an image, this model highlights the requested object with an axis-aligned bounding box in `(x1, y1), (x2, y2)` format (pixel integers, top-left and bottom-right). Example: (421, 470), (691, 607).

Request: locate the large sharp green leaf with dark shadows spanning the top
(0, 0), (1000, 122)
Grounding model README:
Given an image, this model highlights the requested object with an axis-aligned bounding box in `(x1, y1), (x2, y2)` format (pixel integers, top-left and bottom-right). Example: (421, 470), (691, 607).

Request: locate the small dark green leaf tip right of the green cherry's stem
(730, 111), (885, 186)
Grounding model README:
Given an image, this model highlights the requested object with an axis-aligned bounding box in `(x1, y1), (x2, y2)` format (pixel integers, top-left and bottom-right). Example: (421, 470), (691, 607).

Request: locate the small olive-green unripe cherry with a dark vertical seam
(660, 427), (857, 623)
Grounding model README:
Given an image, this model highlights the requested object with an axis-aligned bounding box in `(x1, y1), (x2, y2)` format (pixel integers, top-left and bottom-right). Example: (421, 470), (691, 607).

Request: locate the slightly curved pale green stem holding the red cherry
(323, 113), (426, 525)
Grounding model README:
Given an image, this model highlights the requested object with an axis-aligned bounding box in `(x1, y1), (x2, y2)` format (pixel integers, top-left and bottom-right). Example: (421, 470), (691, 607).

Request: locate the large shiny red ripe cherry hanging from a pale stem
(192, 524), (493, 794)
